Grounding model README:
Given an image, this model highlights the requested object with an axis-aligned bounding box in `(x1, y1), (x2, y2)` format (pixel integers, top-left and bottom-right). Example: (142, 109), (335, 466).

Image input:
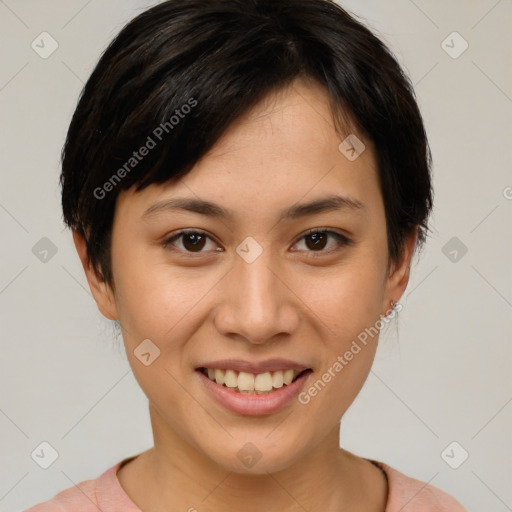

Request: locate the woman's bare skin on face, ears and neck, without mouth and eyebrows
(74, 79), (416, 512)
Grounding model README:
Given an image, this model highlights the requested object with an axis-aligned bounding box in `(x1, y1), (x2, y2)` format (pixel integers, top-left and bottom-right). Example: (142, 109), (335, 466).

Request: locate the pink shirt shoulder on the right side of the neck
(371, 461), (467, 512)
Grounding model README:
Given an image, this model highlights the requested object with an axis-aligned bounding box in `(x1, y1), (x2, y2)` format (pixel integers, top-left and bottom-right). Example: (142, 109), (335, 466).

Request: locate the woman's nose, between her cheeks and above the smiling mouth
(214, 244), (301, 344)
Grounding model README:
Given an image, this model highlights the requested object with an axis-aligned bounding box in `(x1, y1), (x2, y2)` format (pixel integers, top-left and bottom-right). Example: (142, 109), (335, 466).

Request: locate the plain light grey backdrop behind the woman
(0, 0), (512, 512)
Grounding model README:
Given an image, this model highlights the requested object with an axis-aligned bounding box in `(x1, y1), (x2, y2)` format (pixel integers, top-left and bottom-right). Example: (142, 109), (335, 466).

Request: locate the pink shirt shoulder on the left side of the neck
(24, 459), (141, 512)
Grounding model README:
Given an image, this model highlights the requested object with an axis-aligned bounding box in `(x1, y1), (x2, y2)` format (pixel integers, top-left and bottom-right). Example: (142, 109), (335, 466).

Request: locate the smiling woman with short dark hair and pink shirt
(25, 0), (464, 512)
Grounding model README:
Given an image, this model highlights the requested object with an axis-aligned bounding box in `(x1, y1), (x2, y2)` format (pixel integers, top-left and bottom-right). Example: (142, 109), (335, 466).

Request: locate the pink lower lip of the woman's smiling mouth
(196, 370), (312, 416)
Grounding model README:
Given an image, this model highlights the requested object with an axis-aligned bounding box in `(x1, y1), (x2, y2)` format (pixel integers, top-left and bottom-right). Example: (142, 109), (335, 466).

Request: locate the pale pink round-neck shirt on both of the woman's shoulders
(25, 457), (467, 512)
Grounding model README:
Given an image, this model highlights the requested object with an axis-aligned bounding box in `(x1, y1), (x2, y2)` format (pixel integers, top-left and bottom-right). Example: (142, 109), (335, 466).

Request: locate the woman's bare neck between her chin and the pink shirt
(118, 407), (386, 512)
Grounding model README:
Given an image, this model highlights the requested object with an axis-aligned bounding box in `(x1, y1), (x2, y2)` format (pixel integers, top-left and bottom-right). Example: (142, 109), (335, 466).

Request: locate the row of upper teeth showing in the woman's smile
(205, 368), (300, 395)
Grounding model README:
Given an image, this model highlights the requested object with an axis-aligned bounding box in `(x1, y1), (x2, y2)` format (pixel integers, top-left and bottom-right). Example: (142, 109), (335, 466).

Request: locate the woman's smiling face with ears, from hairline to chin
(79, 77), (415, 473)
